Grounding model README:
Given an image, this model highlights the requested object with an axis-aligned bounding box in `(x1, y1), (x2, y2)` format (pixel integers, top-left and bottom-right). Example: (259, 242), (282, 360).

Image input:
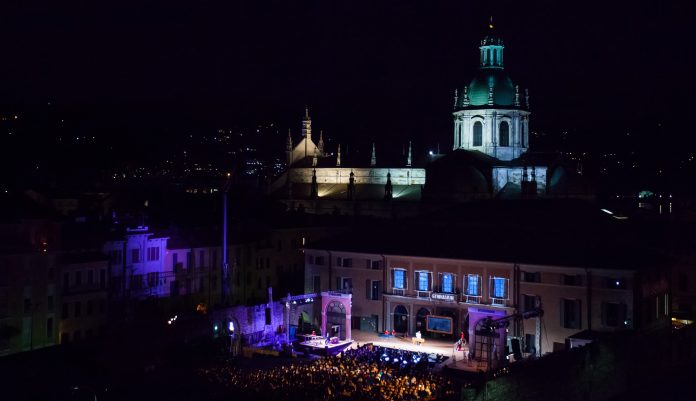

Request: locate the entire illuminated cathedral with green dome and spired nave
(270, 25), (589, 212)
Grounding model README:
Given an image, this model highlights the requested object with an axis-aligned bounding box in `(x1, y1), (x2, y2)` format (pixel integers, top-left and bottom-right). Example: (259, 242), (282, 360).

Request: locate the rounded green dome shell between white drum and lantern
(468, 68), (515, 106)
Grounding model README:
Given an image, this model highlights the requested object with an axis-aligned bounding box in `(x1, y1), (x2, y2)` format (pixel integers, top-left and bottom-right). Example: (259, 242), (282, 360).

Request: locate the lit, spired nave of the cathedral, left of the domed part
(269, 104), (425, 216)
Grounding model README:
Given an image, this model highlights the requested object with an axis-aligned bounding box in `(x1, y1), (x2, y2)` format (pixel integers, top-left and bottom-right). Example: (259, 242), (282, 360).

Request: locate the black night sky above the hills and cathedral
(0, 0), (696, 149)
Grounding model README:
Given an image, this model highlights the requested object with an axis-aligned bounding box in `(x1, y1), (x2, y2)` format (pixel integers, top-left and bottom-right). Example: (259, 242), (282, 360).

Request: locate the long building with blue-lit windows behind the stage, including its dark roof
(305, 200), (647, 353)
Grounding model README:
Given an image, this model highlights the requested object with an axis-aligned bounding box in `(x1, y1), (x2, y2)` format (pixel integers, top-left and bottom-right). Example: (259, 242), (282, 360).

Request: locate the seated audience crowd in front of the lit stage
(201, 345), (455, 401)
